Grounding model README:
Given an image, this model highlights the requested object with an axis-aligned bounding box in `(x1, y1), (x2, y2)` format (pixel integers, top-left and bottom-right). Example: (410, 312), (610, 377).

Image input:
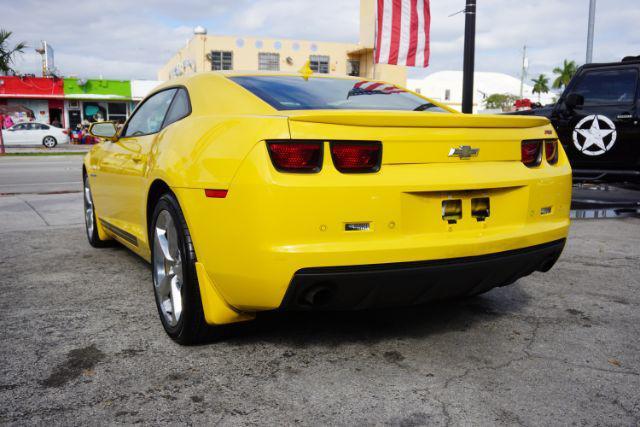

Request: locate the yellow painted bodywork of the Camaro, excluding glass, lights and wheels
(85, 73), (571, 324)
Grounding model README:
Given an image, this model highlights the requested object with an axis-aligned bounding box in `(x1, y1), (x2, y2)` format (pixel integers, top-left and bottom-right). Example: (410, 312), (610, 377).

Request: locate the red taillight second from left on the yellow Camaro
(331, 141), (382, 173)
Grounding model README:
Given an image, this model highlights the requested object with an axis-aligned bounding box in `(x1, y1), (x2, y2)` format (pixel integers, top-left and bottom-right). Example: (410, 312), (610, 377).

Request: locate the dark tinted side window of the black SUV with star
(573, 68), (638, 105)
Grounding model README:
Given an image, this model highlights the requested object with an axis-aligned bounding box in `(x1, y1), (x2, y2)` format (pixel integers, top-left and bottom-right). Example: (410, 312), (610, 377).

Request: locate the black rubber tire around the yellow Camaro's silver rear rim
(149, 193), (210, 345)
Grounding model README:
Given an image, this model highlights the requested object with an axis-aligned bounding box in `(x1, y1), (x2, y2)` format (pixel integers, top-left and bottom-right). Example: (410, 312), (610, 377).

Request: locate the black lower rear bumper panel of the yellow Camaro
(280, 239), (565, 310)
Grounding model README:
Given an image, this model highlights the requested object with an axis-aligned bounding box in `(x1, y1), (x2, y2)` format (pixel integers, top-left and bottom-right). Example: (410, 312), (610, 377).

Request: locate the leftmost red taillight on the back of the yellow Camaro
(267, 140), (322, 173)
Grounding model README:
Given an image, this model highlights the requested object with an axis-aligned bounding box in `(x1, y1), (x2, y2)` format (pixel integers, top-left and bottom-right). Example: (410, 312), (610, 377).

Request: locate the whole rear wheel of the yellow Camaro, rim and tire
(150, 193), (212, 344)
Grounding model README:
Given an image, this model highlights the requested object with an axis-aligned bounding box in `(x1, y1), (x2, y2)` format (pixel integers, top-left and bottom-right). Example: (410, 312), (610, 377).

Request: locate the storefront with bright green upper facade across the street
(64, 78), (131, 129)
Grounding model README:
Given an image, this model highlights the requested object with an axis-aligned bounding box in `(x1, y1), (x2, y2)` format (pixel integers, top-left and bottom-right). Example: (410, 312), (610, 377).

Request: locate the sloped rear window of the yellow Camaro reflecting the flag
(229, 76), (447, 113)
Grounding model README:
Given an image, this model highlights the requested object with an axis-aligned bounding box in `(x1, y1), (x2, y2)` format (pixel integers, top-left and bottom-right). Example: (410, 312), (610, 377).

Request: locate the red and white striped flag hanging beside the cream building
(374, 0), (431, 67)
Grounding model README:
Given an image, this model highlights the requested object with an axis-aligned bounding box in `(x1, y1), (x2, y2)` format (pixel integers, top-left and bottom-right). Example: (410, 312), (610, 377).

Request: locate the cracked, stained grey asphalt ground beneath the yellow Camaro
(0, 186), (640, 426)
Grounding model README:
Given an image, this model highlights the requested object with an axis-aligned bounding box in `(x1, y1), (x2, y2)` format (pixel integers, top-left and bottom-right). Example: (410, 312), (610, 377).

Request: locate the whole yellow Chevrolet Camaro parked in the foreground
(83, 73), (571, 344)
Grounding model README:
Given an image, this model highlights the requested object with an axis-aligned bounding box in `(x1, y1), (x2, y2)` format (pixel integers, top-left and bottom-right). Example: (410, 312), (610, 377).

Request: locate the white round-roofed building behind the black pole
(407, 71), (554, 113)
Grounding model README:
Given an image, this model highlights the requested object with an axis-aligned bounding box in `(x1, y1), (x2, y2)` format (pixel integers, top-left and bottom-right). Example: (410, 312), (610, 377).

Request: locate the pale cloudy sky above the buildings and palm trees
(5, 0), (640, 85)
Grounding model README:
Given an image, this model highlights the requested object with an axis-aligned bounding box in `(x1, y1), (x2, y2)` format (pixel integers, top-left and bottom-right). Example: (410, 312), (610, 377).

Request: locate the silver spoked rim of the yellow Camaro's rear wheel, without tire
(153, 210), (184, 327)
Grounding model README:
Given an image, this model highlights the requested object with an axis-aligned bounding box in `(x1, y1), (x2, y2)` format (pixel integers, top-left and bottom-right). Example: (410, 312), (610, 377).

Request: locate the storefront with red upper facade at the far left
(0, 76), (67, 126)
